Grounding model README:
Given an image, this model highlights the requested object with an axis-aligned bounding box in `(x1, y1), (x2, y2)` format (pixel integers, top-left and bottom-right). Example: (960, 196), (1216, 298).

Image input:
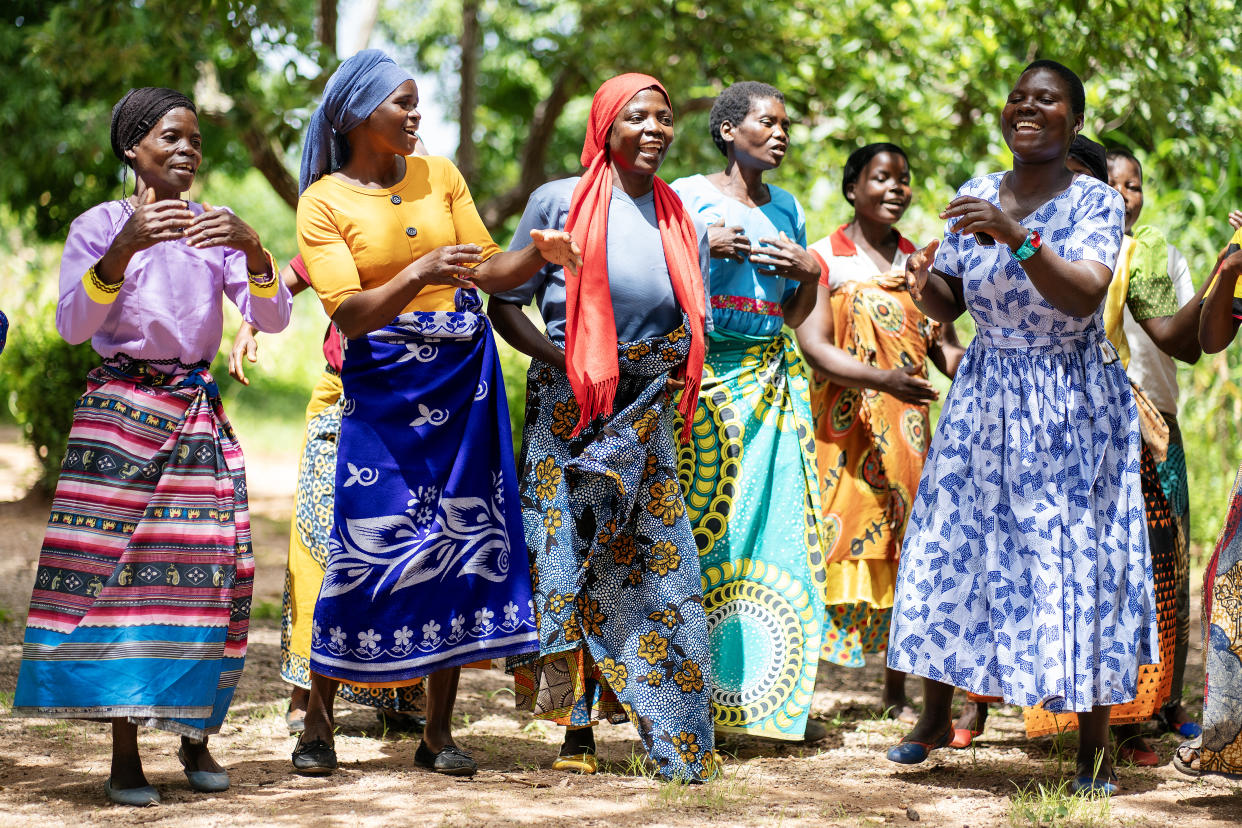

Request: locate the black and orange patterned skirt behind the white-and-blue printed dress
(1023, 443), (1177, 739)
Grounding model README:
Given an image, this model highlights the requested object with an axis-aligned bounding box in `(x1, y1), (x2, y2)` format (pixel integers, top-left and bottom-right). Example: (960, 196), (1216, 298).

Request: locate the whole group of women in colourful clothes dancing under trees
(14, 50), (1242, 804)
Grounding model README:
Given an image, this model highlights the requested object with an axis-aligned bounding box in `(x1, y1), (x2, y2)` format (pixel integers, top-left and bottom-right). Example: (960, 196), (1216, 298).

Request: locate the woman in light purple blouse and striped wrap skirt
(12, 87), (292, 806)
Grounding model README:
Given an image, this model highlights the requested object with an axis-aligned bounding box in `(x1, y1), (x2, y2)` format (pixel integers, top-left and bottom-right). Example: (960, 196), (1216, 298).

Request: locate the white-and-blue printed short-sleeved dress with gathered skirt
(888, 173), (1159, 713)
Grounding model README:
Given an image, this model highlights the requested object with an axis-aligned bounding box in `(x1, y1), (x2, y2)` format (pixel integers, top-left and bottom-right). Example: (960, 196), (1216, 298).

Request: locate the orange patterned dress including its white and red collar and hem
(811, 226), (940, 667)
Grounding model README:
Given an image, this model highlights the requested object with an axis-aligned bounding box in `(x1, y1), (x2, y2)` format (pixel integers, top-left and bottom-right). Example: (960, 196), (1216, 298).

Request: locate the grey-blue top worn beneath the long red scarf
(496, 176), (712, 343)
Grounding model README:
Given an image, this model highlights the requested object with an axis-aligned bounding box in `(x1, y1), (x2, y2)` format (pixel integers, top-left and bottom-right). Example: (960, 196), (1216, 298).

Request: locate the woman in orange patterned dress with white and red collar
(797, 144), (963, 721)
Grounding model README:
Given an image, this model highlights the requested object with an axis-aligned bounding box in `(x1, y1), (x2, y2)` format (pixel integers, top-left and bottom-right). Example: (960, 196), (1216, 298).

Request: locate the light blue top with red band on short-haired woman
(671, 175), (806, 336)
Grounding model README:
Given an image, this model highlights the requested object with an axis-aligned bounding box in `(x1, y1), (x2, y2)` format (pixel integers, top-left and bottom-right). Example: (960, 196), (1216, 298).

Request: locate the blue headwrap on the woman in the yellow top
(298, 48), (414, 194)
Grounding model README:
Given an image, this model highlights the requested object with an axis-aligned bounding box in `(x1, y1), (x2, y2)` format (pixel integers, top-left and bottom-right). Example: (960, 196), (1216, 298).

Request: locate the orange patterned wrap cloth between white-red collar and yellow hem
(811, 273), (939, 566)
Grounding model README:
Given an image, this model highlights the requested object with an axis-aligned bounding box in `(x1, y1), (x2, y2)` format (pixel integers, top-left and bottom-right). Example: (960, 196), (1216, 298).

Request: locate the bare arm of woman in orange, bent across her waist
(794, 284), (936, 403)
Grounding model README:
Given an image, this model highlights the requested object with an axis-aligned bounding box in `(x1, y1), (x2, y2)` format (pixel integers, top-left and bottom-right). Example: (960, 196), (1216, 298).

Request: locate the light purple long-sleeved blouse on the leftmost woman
(56, 201), (293, 365)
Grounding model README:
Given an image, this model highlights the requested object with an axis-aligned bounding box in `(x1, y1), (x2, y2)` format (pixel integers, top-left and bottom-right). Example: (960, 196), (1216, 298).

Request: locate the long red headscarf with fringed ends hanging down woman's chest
(565, 73), (705, 439)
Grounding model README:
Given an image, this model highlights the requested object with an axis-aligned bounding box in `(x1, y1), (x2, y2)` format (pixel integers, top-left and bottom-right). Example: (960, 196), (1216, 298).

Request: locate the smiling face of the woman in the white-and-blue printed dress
(1001, 67), (1083, 164)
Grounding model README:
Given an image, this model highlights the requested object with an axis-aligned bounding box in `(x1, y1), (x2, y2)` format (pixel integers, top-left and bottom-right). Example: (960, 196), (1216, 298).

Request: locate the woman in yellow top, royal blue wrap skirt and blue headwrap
(293, 50), (580, 776)
